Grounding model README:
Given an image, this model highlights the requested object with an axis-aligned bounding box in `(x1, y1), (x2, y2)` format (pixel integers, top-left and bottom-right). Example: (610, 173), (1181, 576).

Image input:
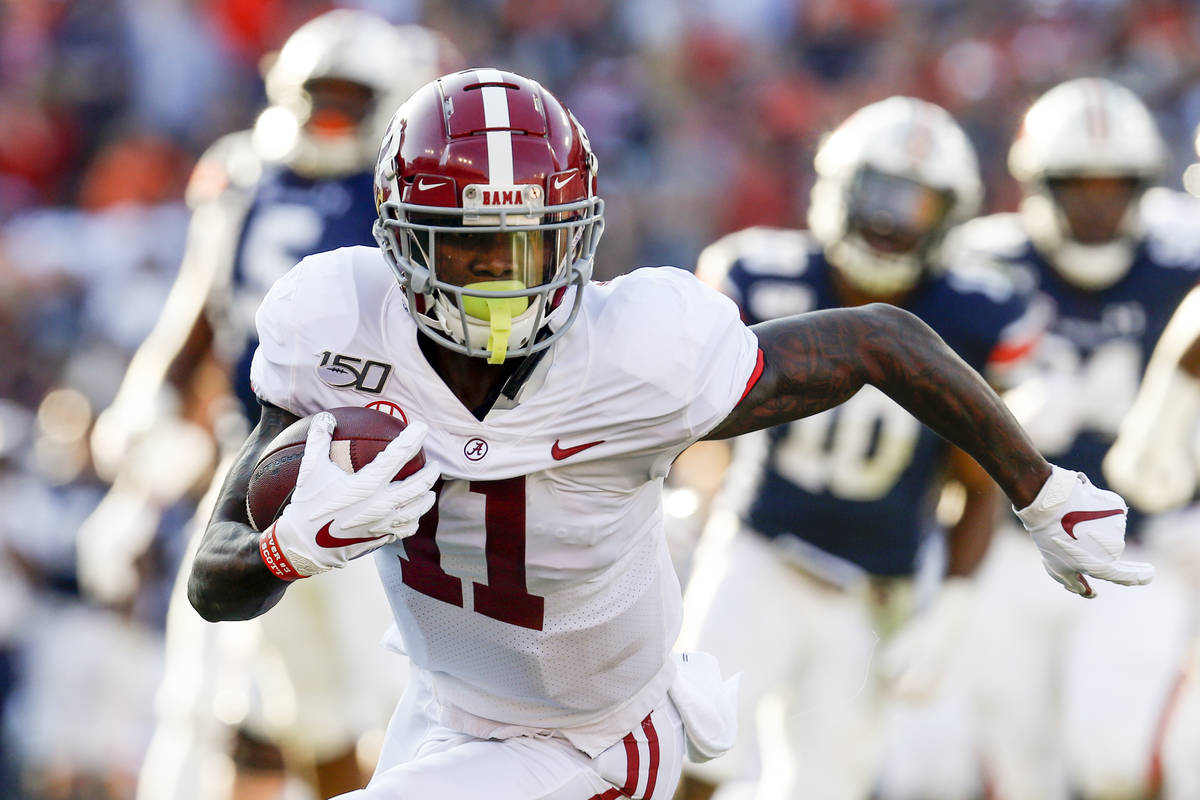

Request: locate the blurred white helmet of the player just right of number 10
(1008, 78), (1166, 290)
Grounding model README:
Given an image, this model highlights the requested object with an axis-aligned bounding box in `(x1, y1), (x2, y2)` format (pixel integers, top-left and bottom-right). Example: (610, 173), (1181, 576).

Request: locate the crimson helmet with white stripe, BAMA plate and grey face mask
(374, 68), (604, 363)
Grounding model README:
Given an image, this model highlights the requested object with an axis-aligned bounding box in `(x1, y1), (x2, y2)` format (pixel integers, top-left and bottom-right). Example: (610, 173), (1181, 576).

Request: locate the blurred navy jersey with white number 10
(698, 228), (1036, 576)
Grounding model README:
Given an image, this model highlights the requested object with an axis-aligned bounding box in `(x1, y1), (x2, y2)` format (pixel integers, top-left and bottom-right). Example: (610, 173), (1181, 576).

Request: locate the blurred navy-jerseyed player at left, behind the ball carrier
(79, 10), (455, 800)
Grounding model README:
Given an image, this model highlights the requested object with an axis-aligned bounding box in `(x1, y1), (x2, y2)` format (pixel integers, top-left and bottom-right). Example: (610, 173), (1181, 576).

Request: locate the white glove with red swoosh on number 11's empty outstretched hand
(1014, 467), (1154, 597)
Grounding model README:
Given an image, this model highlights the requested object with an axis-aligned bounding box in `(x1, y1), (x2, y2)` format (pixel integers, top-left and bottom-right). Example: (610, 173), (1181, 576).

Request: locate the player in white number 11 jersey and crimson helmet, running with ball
(188, 68), (1152, 800)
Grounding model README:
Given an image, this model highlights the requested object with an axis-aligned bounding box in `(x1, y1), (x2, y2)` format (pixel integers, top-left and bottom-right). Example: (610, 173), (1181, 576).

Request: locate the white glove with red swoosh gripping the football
(258, 413), (440, 581)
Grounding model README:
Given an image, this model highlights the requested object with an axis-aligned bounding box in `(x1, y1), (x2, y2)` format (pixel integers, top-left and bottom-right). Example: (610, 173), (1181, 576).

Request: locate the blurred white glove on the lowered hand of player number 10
(880, 577), (976, 703)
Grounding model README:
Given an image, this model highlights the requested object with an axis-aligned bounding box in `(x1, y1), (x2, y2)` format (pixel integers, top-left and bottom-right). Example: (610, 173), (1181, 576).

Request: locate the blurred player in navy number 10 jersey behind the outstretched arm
(680, 97), (1040, 800)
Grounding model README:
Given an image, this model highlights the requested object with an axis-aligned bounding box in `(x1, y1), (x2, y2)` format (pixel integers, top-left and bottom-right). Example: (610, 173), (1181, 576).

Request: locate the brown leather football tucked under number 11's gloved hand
(246, 405), (425, 530)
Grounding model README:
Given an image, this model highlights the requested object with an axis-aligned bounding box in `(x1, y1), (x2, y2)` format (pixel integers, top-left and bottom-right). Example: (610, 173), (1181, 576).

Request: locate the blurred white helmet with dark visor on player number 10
(809, 96), (983, 297)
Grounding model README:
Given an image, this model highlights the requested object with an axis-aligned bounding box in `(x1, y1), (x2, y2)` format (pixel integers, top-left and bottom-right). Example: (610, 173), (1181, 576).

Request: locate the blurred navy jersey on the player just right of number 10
(959, 190), (1200, 536)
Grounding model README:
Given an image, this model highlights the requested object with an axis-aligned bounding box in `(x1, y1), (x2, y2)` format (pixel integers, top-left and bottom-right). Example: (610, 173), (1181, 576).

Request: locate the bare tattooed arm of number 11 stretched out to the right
(707, 303), (1050, 509)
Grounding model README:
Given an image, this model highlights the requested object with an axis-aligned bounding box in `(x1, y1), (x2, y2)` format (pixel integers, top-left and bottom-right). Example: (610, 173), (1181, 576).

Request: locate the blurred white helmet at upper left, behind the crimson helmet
(254, 8), (456, 178)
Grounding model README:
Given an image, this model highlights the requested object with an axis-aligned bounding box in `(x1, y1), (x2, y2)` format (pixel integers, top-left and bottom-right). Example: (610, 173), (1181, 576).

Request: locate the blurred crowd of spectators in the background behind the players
(0, 0), (1200, 800)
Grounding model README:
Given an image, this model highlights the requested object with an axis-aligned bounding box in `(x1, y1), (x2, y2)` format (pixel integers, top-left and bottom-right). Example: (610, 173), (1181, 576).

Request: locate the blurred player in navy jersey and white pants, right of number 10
(948, 78), (1200, 798)
